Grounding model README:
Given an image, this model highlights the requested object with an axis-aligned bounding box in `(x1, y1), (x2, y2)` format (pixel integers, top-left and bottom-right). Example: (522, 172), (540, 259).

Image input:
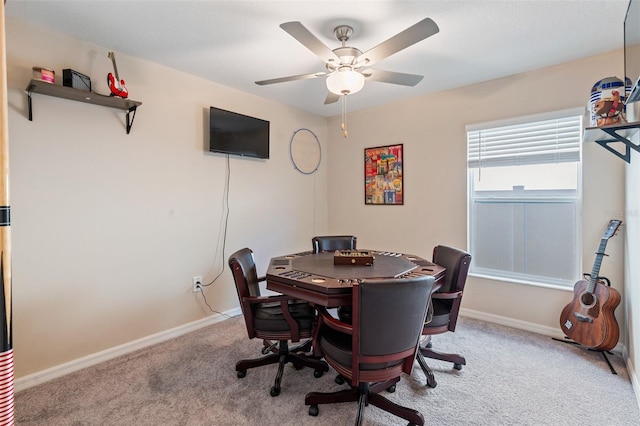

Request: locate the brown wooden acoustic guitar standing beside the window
(560, 220), (622, 351)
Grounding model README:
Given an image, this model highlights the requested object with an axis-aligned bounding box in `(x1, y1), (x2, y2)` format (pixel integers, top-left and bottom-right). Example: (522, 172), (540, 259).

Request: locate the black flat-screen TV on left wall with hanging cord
(209, 107), (269, 158)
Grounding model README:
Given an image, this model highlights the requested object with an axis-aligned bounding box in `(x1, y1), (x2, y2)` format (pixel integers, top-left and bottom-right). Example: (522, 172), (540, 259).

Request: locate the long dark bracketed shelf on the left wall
(27, 80), (142, 134)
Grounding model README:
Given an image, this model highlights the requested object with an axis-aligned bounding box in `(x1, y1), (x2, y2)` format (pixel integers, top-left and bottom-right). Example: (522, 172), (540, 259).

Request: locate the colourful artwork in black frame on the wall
(364, 144), (404, 205)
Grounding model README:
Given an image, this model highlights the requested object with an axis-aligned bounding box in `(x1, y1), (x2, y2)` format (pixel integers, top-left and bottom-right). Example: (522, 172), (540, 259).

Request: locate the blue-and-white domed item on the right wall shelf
(589, 77), (631, 127)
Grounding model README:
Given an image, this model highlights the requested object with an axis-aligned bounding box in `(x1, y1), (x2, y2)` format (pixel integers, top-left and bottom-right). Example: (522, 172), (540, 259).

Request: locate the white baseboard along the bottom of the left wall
(14, 308), (242, 392)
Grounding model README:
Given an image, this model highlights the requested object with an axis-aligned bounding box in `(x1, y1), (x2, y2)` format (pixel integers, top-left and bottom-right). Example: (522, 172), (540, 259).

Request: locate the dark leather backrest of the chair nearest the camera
(352, 275), (434, 364)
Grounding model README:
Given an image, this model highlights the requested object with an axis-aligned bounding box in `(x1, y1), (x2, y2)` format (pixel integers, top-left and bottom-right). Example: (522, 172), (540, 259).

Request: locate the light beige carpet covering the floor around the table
(16, 317), (640, 426)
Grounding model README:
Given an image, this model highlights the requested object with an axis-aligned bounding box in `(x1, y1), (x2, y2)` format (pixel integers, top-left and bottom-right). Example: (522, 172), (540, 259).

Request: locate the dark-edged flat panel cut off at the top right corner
(624, 0), (640, 103)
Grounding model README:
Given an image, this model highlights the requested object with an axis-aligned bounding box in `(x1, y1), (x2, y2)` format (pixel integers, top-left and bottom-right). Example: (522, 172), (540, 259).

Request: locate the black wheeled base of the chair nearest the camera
(304, 377), (424, 426)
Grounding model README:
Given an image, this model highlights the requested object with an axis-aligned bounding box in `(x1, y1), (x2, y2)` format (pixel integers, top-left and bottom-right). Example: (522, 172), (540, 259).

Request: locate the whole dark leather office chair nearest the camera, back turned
(304, 276), (434, 425)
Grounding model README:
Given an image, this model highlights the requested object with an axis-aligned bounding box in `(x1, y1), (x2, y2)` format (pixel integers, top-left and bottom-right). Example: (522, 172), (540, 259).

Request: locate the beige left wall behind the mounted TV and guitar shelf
(7, 19), (327, 378)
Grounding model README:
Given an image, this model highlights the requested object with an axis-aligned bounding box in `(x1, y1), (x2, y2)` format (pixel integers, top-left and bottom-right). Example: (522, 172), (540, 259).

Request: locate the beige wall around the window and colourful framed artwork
(328, 51), (625, 335)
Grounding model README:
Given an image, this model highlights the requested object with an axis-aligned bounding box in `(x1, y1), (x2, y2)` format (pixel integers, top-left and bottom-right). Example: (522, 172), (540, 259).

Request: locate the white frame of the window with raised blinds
(466, 108), (585, 290)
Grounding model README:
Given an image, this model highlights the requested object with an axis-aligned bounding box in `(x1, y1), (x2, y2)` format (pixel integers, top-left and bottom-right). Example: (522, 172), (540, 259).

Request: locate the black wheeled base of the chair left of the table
(236, 340), (329, 396)
